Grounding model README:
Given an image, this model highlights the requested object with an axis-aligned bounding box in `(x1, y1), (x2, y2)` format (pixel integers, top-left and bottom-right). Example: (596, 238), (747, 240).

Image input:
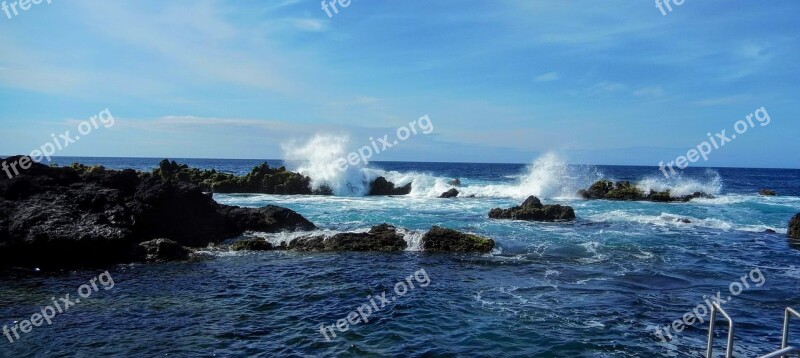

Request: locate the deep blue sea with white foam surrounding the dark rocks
(0, 156), (800, 357)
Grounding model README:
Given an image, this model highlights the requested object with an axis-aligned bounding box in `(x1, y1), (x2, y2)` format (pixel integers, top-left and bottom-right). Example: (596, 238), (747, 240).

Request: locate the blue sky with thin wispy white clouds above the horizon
(0, 0), (800, 168)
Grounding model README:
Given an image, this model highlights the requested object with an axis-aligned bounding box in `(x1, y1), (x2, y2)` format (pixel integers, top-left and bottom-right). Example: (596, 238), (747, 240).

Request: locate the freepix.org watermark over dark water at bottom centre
(319, 268), (431, 342)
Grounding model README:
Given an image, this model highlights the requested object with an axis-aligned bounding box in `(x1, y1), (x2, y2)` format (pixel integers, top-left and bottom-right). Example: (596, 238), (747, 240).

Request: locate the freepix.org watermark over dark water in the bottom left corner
(3, 271), (114, 344)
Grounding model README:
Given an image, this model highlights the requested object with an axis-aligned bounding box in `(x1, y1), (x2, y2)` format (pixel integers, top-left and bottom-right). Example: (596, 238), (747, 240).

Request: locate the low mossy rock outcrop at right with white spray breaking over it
(578, 180), (713, 202)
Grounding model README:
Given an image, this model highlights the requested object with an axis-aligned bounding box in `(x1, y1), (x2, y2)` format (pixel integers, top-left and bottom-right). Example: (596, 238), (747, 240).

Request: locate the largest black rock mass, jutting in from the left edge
(0, 157), (314, 269)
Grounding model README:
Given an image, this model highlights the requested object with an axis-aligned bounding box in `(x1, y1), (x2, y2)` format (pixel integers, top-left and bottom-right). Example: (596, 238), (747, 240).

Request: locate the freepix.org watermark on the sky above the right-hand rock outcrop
(658, 106), (772, 178)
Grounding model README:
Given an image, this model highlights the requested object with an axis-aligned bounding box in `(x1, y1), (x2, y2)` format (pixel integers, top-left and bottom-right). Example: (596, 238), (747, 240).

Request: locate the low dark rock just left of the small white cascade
(287, 224), (407, 252)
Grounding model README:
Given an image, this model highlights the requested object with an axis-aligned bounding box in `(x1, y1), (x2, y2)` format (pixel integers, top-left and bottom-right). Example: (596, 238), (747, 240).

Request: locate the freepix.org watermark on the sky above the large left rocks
(0, 108), (114, 179)
